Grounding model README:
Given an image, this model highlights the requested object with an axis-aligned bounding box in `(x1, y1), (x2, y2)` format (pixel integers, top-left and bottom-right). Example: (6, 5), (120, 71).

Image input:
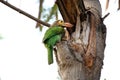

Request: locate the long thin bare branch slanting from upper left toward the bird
(0, 0), (50, 27)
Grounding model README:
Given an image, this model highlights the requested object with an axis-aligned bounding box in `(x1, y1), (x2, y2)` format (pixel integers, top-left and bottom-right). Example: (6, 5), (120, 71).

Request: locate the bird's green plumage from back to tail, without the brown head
(43, 26), (65, 64)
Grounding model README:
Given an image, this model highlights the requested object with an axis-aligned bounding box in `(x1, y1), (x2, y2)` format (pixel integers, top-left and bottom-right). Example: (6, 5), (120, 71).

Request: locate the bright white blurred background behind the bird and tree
(0, 0), (120, 80)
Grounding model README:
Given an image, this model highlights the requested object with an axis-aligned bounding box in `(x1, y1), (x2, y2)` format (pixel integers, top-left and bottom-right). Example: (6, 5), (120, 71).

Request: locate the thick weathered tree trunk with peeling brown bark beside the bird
(55, 0), (106, 80)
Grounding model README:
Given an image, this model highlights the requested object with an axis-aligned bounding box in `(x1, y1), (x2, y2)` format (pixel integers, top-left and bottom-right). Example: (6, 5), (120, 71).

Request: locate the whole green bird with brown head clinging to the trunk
(43, 20), (72, 65)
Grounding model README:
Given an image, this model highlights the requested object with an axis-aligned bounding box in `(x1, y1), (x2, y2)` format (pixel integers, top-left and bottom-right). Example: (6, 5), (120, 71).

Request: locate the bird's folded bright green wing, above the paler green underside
(43, 26), (64, 42)
